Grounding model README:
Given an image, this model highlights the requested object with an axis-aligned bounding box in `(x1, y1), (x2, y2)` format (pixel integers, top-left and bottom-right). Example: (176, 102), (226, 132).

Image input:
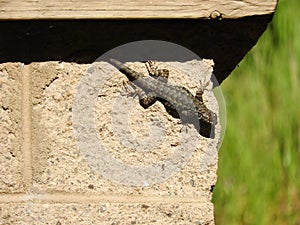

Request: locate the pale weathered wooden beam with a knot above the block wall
(0, 0), (277, 20)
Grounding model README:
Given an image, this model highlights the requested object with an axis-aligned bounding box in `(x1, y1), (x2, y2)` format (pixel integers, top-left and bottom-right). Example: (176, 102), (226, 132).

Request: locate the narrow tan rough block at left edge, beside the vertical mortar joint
(0, 63), (24, 193)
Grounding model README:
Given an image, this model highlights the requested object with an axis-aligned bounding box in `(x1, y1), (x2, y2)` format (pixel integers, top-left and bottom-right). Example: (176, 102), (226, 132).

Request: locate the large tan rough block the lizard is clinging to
(31, 61), (219, 196)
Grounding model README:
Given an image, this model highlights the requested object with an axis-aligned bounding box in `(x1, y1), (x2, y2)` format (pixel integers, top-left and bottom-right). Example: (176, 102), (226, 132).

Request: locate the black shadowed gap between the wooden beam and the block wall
(0, 15), (272, 83)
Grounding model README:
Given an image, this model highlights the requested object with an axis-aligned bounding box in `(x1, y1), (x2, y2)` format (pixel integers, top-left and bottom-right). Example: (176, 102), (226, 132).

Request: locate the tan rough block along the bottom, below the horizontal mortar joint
(0, 202), (213, 225)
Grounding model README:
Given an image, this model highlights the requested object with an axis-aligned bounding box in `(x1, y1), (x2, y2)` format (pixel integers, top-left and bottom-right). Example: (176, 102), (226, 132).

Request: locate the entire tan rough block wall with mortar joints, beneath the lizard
(0, 60), (220, 224)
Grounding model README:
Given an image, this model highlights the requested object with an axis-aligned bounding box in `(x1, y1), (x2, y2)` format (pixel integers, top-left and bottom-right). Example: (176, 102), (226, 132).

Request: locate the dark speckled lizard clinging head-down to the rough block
(108, 59), (217, 138)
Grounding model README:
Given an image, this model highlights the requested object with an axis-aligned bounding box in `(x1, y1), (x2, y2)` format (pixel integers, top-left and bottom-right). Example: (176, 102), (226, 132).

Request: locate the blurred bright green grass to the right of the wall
(213, 0), (300, 225)
